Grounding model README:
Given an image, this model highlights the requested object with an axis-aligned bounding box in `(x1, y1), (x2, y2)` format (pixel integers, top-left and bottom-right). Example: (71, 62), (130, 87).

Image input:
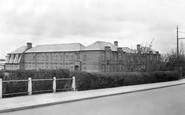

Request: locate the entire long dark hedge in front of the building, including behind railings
(0, 69), (179, 97)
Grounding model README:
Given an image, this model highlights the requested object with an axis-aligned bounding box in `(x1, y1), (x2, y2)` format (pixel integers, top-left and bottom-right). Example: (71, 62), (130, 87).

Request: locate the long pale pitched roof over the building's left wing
(26, 43), (85, 53)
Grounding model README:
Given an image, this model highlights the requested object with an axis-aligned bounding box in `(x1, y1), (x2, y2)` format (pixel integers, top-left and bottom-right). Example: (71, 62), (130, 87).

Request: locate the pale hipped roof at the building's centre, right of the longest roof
(82, 41), (117, 51)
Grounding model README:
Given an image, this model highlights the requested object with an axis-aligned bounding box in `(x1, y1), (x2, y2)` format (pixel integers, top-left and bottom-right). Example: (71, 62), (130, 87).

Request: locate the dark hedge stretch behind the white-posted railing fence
(0, 69), (72, 96)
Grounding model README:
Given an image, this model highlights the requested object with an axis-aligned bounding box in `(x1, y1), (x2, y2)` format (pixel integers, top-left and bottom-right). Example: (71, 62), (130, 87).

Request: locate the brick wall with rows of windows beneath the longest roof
(25, 52), (78, 70)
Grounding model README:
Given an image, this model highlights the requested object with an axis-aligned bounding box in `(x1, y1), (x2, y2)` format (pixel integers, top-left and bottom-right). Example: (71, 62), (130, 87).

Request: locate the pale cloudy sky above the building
(0, 0), (185, 58)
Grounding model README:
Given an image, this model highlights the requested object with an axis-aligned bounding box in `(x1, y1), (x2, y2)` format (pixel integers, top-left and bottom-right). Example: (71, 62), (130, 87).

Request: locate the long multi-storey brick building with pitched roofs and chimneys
(5, 41), (160, 72)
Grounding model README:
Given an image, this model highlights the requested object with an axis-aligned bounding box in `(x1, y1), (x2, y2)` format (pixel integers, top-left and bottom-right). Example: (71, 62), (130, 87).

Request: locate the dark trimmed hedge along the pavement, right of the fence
(71, 71), (179, 91)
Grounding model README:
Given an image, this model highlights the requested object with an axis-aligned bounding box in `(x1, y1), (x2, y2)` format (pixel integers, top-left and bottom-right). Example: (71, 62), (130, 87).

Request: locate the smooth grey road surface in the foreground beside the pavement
(2, 85), (185, 115)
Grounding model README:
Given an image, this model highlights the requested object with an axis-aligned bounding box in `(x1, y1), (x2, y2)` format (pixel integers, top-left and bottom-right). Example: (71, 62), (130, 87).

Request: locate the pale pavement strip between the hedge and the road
(0, 79), (185, 115)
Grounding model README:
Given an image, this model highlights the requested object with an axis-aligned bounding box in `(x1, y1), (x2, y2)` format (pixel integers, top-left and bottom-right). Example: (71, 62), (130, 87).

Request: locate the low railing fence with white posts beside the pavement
(0, 77), (76, 98)
